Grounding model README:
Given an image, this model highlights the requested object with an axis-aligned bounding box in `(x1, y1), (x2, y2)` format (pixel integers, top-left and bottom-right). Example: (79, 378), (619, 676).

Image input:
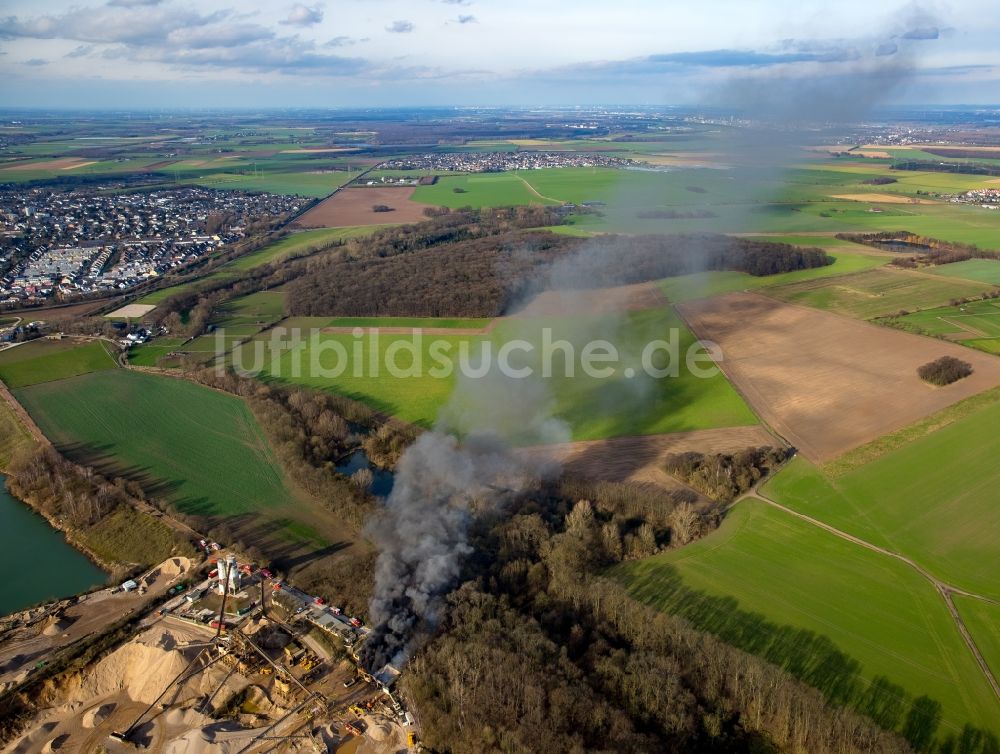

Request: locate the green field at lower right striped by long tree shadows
(613, 496), (1000, 738)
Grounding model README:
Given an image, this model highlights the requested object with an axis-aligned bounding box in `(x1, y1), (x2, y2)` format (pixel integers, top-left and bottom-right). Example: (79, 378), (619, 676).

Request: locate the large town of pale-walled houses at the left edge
(0, 187), (303, 304)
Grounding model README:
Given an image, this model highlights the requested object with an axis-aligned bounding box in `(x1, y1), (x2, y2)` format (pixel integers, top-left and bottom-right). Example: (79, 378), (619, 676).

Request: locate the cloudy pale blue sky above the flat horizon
(0, 0), (1000, 108)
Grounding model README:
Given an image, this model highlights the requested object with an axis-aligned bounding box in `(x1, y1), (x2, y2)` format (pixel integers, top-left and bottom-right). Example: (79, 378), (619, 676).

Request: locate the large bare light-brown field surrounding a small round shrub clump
(678, 293), (1000, 462)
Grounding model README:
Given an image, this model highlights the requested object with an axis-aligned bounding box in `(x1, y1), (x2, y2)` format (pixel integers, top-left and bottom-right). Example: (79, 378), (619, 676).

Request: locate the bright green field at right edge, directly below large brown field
(764, 391), (1000, 600)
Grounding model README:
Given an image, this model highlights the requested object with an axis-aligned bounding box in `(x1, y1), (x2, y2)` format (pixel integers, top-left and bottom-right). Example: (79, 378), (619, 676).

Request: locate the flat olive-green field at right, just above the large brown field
(767, 268), (992, 319)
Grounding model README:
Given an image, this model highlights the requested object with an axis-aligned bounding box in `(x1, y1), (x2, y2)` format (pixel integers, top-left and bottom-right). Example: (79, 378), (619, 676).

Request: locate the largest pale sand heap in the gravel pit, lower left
(70, 635), (188, 704)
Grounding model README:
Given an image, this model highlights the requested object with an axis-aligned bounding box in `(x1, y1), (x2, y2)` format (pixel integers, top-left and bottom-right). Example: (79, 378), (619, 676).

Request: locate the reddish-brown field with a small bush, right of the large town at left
(295, 186), (432, 228)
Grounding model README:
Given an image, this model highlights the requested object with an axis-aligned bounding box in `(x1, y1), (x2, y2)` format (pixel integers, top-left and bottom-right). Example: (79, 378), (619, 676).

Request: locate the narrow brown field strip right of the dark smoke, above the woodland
(519, 425), (782, 489)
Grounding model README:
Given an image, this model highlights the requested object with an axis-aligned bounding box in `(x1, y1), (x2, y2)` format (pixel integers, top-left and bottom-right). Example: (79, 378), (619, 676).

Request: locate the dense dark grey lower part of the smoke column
(361, 373), (569, 672)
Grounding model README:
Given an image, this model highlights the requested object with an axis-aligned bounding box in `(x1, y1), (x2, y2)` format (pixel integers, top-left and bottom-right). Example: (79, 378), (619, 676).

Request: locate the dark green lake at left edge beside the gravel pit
(0, 475), (107, 615)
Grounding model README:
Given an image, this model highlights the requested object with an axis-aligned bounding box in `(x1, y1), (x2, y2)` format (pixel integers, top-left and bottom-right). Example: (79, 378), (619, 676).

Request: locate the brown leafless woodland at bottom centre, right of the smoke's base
(401, 480), (932, 754)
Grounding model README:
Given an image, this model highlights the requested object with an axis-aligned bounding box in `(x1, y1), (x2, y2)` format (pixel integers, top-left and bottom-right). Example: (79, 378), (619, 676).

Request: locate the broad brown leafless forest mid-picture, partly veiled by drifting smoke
(286, 216), (833, 317)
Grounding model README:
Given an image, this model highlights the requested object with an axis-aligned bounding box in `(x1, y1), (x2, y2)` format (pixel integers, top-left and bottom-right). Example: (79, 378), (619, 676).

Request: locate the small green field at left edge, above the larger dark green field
(0, 339), (117, 388)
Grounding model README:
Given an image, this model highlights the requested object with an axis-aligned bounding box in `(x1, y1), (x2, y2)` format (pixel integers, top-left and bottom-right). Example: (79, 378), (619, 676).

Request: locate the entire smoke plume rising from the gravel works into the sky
(361, 1), (936, 672)
